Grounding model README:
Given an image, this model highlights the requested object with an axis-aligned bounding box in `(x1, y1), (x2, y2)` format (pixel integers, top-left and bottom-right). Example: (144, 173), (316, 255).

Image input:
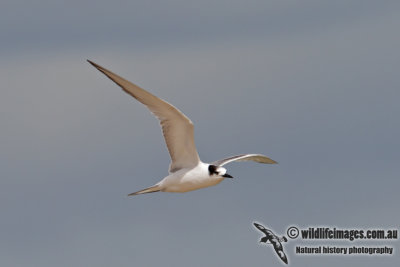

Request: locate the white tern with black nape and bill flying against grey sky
(88, 60), (277, 196)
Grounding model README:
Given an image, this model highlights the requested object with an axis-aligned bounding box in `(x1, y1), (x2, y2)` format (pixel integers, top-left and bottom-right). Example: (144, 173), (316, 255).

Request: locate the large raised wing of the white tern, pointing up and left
(88, 60), (200, 173)
